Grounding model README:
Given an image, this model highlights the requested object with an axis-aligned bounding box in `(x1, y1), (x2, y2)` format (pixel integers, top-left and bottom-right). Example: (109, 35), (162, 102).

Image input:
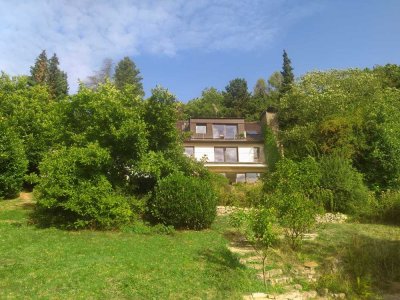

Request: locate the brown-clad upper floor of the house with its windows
(177, 118), (262, 143)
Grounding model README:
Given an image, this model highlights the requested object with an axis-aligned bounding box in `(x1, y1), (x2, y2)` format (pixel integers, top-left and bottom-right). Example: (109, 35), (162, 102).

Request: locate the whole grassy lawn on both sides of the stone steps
(0, 195), (400, 299)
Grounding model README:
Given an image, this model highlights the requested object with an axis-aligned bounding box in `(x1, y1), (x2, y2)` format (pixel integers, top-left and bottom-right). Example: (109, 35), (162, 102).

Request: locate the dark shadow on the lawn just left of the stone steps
(199, 247), (246, 270)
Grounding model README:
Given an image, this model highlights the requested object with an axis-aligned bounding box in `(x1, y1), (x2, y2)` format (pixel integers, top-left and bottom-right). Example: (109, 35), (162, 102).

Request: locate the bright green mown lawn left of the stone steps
(0, 199), (263, 299)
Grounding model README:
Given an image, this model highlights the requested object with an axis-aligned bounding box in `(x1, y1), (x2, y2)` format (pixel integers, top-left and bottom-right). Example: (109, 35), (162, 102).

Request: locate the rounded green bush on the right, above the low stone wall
(320, 154), (369, 214)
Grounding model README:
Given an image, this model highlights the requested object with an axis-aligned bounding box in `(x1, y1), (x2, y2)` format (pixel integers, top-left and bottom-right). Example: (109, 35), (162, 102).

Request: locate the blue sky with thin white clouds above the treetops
(0, 0), (400, 102)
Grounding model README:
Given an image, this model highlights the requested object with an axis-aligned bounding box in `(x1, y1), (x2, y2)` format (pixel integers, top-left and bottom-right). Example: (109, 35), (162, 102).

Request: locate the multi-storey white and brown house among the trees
(177, 112), (275, 183)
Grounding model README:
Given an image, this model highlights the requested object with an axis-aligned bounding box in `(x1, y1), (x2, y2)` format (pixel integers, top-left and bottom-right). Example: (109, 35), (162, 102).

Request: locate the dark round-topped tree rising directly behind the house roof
(222, 78), (250, 117)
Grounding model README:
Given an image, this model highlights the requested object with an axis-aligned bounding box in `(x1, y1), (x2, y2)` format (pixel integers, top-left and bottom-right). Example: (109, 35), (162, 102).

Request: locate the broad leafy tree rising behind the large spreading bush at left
(61, 83), (147, 187)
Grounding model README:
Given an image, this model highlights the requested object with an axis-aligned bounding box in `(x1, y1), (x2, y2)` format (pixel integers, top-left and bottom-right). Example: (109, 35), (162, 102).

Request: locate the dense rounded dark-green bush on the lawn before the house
(150, 173), (217, 230)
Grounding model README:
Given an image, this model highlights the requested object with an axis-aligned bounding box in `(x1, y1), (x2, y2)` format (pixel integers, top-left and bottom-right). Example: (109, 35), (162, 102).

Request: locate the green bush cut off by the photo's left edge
(0, 119), (28, 199)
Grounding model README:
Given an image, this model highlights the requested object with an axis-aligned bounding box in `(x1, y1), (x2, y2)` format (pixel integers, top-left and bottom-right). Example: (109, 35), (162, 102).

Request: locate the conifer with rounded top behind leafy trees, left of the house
(114, 57), (144, 95)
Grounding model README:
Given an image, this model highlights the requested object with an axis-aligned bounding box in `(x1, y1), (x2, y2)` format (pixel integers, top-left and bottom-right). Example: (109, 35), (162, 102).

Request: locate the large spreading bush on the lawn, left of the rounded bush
(35, 144), (134, 229)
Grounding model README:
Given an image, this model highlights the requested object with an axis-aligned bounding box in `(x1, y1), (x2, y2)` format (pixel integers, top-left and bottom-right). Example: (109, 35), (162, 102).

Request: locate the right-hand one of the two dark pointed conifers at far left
(47, 53), (68, 99)
